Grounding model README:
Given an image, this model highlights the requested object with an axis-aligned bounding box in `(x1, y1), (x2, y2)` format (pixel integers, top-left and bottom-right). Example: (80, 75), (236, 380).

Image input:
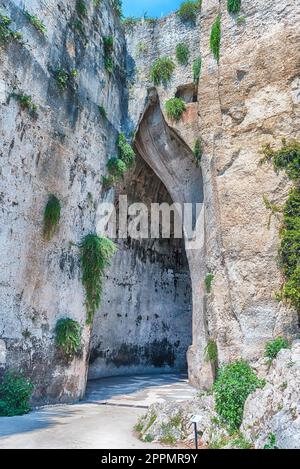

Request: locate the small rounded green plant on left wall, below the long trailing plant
(55, 318), (81, 359)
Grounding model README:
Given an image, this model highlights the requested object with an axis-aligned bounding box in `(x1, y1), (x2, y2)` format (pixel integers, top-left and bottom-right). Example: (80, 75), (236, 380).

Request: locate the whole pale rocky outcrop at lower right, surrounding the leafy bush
(136, 341), (300, 449)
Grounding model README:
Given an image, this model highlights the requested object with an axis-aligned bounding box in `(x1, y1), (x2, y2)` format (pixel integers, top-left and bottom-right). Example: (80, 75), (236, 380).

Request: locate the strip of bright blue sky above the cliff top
(123, 0), (182, 17)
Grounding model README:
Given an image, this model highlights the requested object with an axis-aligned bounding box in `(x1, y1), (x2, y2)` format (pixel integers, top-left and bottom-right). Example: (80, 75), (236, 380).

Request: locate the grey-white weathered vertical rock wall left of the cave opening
(0, 0), (125, 403)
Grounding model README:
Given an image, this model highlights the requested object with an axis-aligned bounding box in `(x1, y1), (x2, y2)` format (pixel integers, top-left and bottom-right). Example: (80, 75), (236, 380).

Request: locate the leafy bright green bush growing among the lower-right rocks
(214, 360), (265, 433)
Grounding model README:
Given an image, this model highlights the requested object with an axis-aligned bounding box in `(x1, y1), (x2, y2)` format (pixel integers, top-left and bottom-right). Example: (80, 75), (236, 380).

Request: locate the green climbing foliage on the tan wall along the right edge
(261, 140), (300, 312)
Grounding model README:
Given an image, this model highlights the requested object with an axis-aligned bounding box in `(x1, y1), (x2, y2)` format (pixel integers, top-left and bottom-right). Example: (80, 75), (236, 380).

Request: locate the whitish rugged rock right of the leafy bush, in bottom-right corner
(242, 341), (300, 449)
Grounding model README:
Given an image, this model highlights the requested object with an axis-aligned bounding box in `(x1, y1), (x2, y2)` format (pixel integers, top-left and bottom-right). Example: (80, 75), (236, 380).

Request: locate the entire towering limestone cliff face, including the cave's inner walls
(0, 0), (300, 403)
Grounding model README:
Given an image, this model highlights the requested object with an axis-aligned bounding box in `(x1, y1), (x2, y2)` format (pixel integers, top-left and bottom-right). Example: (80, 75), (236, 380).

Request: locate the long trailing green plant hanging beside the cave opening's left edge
(80, 234), (117, 325)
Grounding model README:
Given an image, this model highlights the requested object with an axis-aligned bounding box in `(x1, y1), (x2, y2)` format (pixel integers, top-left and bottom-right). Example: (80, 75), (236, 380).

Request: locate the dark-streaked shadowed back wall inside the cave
(89, 155), (192, 379)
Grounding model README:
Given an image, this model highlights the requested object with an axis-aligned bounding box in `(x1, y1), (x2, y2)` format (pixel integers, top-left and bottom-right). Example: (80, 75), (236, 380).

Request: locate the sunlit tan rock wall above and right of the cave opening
(126, 0), (299, 386)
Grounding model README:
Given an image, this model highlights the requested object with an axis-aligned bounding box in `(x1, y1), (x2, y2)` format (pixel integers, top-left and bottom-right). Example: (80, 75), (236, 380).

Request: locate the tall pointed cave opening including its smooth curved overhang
(89, 88), (203, 379)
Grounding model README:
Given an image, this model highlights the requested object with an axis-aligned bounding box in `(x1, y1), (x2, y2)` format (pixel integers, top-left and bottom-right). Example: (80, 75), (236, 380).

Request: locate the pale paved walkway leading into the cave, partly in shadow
(0, 374), (196, 449)
